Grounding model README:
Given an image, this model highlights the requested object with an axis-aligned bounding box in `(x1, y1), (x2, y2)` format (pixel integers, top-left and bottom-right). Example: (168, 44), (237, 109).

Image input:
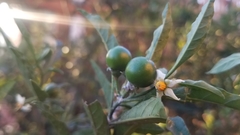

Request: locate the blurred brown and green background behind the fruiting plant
(0, 0), (240, 135)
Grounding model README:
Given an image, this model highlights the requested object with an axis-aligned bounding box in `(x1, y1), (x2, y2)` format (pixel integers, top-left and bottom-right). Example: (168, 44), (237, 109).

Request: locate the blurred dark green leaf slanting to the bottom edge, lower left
(42, 110), (70, 135)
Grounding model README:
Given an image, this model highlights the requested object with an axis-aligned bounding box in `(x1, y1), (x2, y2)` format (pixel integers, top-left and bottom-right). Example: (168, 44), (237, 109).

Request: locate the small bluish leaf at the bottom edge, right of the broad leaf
(167, 116), (190, 135)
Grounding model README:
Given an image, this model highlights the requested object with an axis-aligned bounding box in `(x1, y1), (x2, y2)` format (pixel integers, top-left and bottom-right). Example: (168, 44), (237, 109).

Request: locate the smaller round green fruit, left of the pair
(106, 46), (132, 71)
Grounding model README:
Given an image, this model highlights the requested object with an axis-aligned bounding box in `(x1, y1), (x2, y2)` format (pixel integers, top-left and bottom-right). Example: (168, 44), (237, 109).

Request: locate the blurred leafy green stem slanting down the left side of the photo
(0, 23), (70, 135)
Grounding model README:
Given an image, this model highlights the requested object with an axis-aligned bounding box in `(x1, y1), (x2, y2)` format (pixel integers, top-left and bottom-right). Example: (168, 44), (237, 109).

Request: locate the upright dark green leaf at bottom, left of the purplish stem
(84, 101), (110, 135)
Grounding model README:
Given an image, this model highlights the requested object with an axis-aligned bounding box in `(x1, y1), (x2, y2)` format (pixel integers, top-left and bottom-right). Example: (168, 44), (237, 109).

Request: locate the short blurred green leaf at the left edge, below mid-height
(0, 81), (16, 101)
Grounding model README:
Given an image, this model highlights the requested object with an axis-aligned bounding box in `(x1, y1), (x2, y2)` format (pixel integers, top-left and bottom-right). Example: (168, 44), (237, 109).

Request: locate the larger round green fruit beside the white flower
(125, 57), (157, 87)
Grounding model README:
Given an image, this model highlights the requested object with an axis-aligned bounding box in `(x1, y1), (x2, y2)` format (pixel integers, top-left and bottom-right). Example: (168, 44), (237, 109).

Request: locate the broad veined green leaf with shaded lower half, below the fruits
(110, 97), (166, 135)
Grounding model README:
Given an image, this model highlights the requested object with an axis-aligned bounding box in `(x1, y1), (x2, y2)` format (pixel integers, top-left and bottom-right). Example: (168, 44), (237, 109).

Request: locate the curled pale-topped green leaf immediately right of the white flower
(180, 80), (225, 100)
